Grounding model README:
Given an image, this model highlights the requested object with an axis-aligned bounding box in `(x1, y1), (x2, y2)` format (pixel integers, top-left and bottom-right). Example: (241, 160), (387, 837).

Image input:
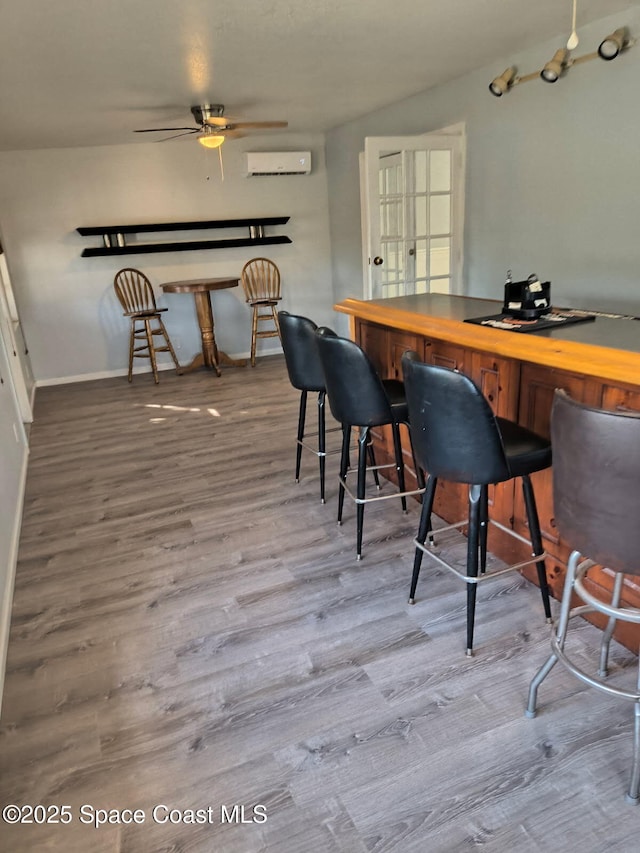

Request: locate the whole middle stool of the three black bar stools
(316, 327), (424, 560)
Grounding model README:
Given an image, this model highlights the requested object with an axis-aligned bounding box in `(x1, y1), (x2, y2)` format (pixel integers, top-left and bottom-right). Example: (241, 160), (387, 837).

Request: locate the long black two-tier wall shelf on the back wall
(76, 216), (291, 258)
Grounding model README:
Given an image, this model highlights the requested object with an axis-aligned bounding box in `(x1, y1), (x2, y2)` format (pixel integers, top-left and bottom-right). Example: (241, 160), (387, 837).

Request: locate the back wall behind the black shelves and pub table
(0, 136), (333, 383)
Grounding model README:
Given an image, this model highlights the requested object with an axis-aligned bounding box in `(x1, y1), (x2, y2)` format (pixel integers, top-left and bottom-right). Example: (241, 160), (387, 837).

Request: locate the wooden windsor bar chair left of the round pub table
(113, 267), (181, 385)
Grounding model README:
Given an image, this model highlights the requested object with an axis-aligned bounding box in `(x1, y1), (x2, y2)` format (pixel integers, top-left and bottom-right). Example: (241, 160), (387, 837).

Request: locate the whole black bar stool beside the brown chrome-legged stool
(402, 352), (551, 655)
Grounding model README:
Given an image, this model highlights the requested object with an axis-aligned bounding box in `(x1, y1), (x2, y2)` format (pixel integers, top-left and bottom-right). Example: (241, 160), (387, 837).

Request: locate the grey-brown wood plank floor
(0, 357), (640, 853)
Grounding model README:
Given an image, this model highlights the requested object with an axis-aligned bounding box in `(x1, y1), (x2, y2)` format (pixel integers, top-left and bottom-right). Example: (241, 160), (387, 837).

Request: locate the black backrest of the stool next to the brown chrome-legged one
(402, 352), (511, 485)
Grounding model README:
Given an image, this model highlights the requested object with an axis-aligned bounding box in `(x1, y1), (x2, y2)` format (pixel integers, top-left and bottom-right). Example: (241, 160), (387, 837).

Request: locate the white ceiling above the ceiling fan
(0, 0), (638, 150)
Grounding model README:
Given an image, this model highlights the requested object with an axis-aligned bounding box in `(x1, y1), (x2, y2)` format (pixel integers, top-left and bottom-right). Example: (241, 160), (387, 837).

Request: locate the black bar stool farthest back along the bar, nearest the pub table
(278, 311), (338, 503)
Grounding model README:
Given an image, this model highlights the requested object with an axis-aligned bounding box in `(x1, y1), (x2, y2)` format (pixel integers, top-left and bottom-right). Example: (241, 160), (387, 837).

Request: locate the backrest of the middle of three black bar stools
(316, 326), (393, 427)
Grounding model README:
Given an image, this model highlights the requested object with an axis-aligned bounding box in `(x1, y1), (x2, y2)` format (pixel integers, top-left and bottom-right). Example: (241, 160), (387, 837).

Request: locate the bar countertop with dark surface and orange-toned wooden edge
(334, 293), (640, 385)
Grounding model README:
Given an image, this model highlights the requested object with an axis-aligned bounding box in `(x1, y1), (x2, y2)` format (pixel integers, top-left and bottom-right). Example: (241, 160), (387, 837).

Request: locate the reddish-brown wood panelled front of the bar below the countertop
(356, 320), (640, 648)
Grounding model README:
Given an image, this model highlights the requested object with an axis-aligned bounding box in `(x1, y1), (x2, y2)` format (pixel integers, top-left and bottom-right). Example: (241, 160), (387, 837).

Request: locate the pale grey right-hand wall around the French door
(327, 8), (640, 330)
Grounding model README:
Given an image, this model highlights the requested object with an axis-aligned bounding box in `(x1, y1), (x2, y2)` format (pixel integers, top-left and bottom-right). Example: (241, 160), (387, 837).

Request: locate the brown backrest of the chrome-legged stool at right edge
(551, 391), (640, 575)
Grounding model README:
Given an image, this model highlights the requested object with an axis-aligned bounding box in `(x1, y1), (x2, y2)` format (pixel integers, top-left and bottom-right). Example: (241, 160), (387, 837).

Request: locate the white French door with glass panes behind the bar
(363, 132), (464, 299)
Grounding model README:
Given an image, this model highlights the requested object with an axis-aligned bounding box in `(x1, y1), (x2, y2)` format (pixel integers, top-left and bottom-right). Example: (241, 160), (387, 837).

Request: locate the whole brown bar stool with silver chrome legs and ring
(526, 391), (640, 803)
